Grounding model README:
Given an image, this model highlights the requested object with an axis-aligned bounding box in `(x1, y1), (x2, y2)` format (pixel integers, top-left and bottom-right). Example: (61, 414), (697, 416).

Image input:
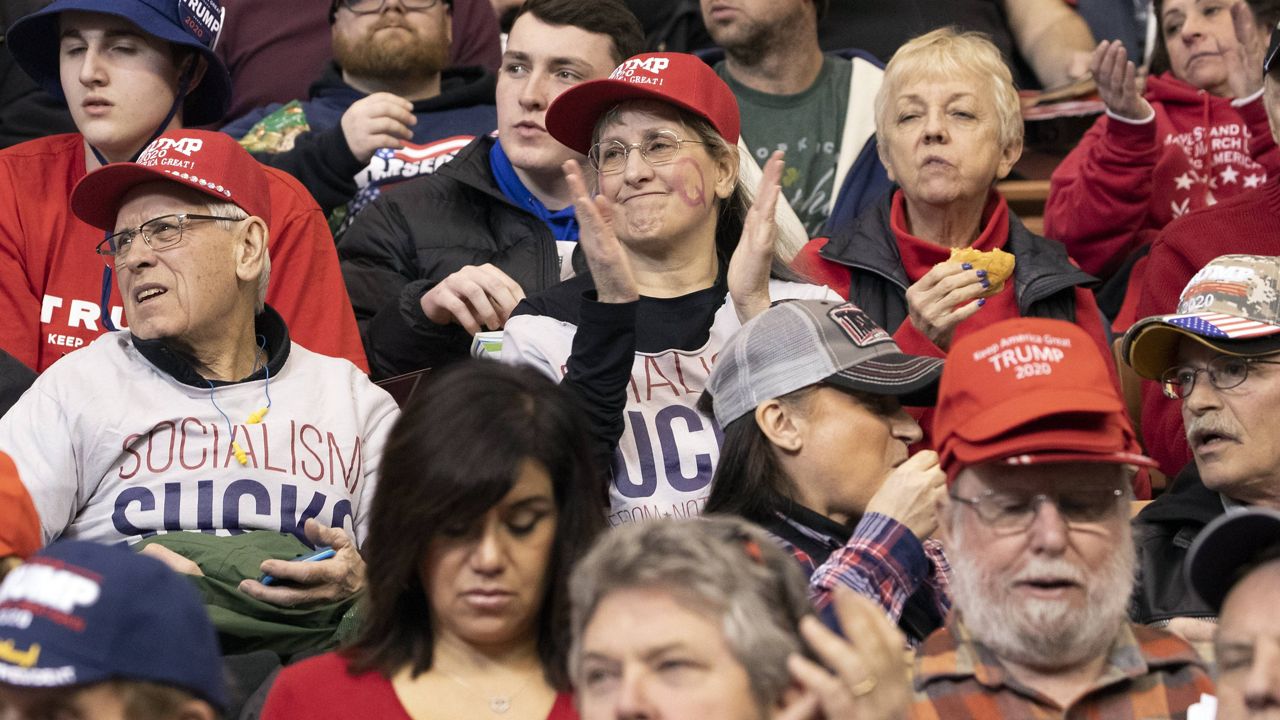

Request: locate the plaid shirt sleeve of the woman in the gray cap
(809, 512), (951, 623)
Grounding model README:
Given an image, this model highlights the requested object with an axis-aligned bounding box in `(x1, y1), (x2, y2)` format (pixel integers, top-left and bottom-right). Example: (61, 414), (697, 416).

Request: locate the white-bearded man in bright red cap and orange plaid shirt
(910, 318), (1213, 720)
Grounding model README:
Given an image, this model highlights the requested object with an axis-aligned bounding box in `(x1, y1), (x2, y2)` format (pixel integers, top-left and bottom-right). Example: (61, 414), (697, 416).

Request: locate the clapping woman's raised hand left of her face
(561, 160), (640, 302)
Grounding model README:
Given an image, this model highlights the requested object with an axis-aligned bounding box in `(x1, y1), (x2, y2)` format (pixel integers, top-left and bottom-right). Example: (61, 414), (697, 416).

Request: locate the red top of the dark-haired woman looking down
(262, 652), (579, 720)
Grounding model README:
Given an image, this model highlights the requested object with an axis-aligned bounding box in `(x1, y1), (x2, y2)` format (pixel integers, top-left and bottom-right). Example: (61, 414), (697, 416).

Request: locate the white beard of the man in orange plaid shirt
(947, 520), (1137, 671)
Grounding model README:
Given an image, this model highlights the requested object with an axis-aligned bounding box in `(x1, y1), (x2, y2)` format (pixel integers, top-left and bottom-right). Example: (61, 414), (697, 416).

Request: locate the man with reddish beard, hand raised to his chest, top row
(223, 0), (497, 213)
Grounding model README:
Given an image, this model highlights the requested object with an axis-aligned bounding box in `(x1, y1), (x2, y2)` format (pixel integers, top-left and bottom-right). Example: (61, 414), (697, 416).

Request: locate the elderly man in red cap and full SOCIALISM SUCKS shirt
(0, 129), (398, 627)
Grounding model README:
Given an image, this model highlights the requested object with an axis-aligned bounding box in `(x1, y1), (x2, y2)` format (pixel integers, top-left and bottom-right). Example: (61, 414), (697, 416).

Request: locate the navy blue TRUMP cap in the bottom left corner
(0, 541), (227, 711)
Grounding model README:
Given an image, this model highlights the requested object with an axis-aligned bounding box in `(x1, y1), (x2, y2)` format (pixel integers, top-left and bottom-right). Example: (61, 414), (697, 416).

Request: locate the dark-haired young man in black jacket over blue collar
(338, 0), (644, 378)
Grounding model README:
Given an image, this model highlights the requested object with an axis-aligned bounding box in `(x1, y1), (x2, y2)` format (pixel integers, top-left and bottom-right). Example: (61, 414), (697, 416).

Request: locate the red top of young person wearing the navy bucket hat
(0, 133), (369, 373)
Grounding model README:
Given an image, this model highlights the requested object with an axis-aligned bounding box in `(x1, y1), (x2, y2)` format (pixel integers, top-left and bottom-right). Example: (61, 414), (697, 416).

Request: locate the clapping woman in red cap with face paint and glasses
(502, 53), (829, 524)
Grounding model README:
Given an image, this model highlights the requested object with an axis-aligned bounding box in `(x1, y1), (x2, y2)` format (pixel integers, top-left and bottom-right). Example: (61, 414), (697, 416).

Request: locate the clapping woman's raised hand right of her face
(726, 150), (786, 323)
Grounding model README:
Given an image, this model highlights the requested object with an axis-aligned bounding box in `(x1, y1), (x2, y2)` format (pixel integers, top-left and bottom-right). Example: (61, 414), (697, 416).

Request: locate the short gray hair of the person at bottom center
(568, 516), (813, 708)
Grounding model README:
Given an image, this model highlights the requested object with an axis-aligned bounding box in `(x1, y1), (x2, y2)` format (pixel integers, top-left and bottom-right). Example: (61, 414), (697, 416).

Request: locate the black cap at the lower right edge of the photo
(1184, 507), (1280, 610)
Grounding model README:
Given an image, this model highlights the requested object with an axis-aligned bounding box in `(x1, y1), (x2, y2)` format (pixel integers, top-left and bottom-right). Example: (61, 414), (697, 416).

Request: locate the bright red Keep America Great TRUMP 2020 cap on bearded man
(933, 318), (1156, 483)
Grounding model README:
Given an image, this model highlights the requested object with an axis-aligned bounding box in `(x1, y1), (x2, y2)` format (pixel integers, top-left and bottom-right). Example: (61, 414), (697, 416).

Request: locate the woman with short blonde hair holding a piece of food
(797, 28), (1136, 486)
